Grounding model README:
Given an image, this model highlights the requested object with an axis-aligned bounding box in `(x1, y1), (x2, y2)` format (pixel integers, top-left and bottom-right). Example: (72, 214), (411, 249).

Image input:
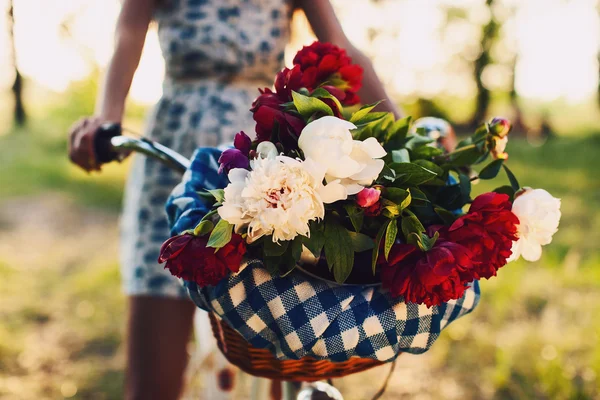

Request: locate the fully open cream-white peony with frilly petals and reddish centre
(218, 156), (335, 243)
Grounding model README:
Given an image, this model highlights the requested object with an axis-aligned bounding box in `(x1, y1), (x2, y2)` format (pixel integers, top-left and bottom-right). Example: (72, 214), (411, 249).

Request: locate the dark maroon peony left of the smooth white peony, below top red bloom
(250, 89), (306, 148)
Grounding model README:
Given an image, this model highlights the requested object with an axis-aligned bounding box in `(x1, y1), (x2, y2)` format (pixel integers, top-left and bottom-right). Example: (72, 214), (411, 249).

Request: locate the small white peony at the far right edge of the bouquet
(508, 188), (560, 261)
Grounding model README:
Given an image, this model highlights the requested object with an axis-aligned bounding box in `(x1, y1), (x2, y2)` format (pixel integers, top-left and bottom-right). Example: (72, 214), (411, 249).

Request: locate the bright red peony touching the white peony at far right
(442, 192), (519, 280)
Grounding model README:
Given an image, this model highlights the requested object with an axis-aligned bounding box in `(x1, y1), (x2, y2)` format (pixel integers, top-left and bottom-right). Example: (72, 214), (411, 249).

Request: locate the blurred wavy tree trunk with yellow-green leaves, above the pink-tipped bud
(470, 0), (500, 127)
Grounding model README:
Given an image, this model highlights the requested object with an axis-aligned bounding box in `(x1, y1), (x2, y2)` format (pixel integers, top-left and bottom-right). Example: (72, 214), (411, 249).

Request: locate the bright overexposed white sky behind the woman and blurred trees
(0, 0), (600, 103)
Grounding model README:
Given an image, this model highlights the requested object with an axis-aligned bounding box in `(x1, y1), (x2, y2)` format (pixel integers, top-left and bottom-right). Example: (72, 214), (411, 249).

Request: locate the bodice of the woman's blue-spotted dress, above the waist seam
(155, 0), (292, 83)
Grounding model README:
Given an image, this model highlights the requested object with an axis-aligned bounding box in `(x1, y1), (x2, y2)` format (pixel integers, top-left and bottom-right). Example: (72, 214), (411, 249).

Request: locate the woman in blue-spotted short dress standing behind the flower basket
(69, 0), (399, 400)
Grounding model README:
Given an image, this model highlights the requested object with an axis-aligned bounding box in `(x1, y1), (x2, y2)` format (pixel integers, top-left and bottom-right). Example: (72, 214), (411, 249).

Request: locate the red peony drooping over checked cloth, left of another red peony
(379, 239), (473, 307)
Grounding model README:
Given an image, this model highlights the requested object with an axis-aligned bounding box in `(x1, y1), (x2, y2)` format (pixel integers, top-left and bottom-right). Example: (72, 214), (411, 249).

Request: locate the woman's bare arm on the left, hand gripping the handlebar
(69, 0), (158, 171)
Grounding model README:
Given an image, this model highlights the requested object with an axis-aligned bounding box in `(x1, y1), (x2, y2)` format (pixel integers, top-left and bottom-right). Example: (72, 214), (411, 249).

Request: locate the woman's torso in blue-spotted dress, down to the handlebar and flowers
(146, 0), (292, 150)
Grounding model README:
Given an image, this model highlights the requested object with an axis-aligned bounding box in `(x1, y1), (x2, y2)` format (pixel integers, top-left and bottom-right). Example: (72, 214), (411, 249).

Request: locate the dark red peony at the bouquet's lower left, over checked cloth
(158, 234), (246, 287)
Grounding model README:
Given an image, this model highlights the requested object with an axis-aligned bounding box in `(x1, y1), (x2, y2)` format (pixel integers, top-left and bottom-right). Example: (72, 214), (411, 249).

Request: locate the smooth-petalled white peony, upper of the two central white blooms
(298, 116), (387, 200)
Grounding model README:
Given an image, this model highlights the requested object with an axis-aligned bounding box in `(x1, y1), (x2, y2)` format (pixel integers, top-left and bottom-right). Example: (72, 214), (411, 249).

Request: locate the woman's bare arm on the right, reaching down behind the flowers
(295, 0), (402, 118)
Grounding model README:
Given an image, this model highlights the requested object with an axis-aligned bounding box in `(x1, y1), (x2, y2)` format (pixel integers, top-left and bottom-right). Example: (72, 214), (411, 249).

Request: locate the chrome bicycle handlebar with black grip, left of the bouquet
(94, 124), (190, 173)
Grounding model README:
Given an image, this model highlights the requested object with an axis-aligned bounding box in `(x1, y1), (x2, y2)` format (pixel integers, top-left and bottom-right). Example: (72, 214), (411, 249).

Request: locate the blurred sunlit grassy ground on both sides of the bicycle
(0, 124), (600, 400)
